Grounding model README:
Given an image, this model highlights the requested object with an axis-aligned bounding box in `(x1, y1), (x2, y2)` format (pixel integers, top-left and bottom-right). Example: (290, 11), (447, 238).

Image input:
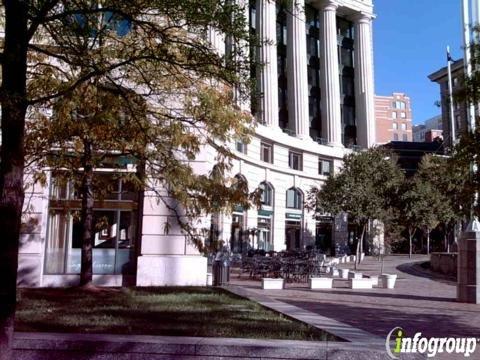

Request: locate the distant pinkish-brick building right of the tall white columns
(375, 93), (412, 144)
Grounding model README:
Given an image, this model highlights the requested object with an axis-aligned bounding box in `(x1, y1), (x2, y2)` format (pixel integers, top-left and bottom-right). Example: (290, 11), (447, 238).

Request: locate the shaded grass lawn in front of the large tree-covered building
(15, 287), (340, 341)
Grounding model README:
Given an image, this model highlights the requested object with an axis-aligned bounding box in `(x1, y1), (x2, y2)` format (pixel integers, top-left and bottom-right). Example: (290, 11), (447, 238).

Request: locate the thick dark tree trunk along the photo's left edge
(0, 0), (28, 360)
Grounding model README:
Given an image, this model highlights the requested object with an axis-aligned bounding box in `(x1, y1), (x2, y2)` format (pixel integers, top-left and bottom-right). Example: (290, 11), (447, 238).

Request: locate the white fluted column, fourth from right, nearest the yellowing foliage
(256, 0), (278, 127)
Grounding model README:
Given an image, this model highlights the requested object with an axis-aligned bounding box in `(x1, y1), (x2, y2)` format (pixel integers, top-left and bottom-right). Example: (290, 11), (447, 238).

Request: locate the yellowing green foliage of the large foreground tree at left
(26, 0), (258, 252)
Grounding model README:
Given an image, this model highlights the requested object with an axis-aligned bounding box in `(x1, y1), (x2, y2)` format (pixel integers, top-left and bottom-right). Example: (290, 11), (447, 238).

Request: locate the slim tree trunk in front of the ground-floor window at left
(80, 140), (95, 287)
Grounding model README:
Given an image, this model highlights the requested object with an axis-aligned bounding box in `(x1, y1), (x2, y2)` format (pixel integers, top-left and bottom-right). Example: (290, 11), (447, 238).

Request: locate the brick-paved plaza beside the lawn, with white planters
(231, 256), (480, 339)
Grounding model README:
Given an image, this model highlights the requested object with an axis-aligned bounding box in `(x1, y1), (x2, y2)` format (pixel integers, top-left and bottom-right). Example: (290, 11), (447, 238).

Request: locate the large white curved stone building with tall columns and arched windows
(19, 0), (375, 286)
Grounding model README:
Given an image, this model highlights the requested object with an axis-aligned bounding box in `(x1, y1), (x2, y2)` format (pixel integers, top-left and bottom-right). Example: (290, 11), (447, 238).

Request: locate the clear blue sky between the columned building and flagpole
(373, 0), (463, 124)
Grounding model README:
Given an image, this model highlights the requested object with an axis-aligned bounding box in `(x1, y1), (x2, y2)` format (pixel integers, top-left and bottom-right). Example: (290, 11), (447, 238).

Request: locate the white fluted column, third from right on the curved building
(287, 0), (310, 139)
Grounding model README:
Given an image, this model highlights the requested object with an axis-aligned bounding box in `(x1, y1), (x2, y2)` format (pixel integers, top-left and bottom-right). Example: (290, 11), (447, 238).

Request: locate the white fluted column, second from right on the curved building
(320, 0), (343, 146)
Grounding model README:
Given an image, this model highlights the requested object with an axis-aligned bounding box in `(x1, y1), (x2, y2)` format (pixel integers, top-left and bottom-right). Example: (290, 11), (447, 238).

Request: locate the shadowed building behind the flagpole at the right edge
(428, 59), (468, 147)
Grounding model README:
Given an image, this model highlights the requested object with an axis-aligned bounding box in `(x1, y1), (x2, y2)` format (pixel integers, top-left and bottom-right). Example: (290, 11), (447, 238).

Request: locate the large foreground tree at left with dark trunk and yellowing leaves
(0, 0), (255, 360)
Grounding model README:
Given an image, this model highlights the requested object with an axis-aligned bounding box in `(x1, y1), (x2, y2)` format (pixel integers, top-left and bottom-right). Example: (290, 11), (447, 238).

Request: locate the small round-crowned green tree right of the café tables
(308, 149), (403, 267)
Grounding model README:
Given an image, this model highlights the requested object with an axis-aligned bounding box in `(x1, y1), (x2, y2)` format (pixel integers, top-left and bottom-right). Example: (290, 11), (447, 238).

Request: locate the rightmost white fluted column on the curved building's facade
(353, 13), (375, 148)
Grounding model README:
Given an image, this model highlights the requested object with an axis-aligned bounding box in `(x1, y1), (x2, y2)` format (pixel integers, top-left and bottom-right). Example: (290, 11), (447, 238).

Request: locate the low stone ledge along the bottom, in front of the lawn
(13, 333), (420, 360)
